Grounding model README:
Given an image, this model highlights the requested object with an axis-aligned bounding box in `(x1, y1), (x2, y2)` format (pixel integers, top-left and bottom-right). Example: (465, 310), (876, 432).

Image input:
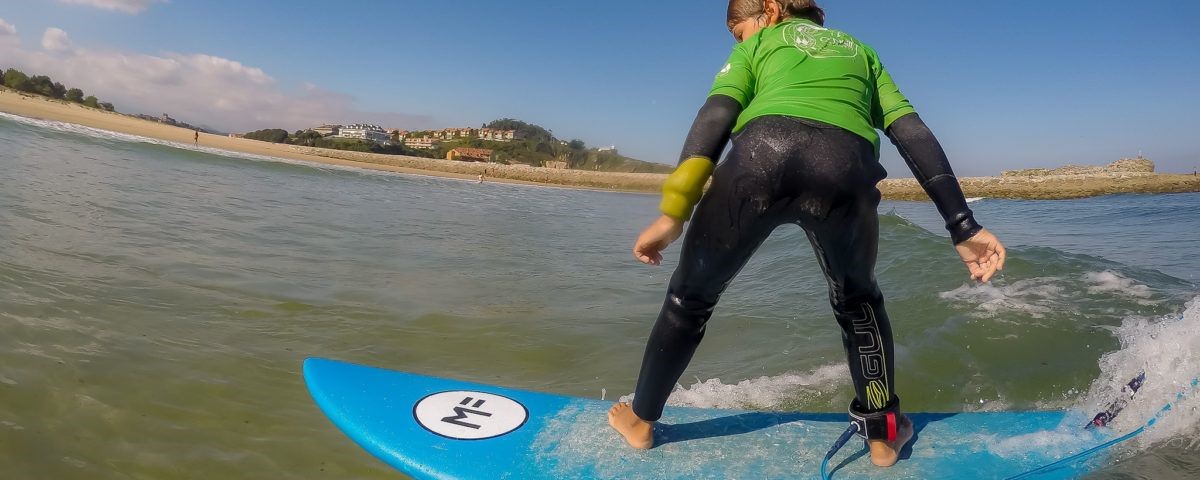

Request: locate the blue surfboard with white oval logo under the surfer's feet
(304, 359), (1115, 479)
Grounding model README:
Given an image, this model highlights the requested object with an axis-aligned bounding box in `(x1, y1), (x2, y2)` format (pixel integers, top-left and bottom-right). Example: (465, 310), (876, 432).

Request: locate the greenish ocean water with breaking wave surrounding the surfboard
(0, 114), (1200, 479)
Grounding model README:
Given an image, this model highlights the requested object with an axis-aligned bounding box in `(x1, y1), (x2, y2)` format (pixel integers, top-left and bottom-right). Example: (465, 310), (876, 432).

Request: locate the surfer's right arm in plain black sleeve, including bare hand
(887, 113), (1006, 282)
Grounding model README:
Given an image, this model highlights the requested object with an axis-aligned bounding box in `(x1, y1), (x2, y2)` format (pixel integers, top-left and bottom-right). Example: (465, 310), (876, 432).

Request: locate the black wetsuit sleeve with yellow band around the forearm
(659, 94), (742, 221)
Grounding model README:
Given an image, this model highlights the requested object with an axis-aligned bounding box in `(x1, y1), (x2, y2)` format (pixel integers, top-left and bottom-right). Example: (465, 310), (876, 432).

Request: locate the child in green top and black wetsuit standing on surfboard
(608, 0), (1006, 467)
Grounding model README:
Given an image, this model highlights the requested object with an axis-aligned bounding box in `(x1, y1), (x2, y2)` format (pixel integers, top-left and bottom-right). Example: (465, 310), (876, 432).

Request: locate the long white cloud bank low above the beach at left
(0, 29), (431, 132)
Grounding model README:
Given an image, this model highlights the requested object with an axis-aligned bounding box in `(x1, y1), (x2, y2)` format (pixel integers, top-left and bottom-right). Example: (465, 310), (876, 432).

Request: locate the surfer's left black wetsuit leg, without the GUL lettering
(634, 126), (785, 421)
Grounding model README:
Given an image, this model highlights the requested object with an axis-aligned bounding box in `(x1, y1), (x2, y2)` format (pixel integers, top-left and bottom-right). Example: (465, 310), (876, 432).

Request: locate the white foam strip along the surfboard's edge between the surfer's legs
(620, 364), (850, 410)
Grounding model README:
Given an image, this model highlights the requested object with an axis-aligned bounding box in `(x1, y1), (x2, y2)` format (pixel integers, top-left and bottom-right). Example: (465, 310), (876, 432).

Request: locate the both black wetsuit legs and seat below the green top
(634, 116), (893, 421)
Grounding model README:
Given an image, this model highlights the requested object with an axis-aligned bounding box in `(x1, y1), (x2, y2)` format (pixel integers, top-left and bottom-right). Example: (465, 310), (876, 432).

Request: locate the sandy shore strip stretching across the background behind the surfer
(0, 89), (1200, 200)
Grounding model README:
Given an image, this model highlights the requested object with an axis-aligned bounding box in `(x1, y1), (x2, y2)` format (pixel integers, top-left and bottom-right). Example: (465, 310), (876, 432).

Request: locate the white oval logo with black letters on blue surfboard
(413, 390), (529, 440)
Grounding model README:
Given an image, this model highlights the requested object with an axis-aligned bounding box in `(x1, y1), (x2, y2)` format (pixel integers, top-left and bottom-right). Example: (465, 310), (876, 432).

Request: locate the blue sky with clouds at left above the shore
(0, 0), (1200, 176)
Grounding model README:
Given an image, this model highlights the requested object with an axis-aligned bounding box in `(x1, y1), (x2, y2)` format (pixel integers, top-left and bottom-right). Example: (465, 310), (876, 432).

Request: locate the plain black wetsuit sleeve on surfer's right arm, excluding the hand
(886, 113), (983, 245)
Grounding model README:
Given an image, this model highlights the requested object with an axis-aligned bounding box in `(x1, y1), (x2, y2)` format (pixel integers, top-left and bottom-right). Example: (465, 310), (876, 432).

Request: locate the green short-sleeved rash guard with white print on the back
(709, 18), (916, 155)
